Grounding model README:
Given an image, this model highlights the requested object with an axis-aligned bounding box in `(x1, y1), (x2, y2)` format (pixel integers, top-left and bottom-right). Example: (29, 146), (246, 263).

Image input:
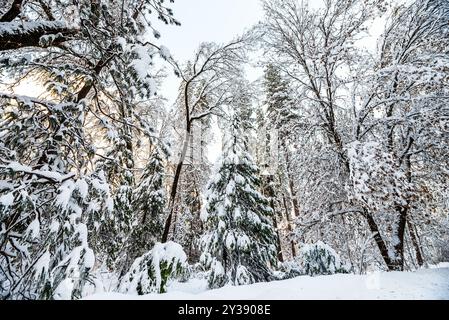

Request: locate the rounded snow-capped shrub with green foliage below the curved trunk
(119, 242), (187, 295)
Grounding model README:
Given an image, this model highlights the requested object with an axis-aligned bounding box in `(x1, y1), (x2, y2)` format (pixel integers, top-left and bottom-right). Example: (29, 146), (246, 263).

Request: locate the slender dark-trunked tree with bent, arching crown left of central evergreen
(162, 35), (251, 242)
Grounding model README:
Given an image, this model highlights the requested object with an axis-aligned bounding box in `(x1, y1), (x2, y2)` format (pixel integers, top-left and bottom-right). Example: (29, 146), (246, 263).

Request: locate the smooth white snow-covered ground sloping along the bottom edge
(86, 263), (449, 300)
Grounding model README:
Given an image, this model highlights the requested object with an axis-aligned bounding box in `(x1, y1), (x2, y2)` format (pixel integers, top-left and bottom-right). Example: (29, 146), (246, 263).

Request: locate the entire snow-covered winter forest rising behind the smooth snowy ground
(0, 0), (449, 300)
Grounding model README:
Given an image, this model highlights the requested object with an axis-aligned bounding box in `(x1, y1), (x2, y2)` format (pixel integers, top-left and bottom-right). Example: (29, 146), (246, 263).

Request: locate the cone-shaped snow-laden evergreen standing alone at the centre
(201, 118), (276, 288)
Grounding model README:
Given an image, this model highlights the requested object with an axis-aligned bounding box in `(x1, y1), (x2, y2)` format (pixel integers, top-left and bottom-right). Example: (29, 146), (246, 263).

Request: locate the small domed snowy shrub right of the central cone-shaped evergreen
(299, 241), (347, 276)
